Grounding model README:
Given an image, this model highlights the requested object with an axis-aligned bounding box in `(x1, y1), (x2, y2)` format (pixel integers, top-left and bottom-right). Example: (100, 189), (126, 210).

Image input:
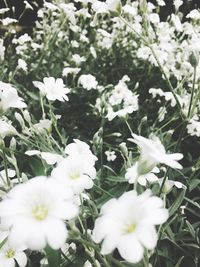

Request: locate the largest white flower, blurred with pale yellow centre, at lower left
(0, 176), (78, 250)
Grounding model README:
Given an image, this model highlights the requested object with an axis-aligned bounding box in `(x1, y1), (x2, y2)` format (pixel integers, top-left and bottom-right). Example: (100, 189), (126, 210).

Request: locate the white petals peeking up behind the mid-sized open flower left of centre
(65, 139), (97, 166)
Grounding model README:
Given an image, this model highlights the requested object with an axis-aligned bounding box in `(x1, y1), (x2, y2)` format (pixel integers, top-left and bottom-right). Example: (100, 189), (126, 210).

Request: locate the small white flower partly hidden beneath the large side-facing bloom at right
(125, 161), (159, 186)
